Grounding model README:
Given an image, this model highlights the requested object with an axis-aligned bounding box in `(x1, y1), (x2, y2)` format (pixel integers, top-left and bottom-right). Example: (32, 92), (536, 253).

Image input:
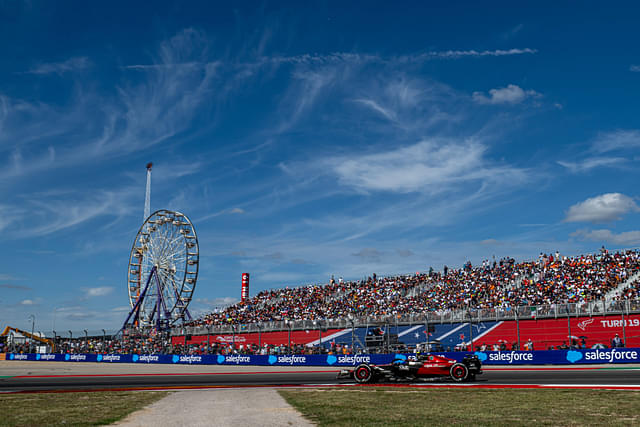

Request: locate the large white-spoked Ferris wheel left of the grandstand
(125, 209), (199, 329)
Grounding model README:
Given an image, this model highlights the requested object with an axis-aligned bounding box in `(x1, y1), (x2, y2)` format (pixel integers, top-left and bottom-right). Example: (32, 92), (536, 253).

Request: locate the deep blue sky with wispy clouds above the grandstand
(0, 0), (640, 331)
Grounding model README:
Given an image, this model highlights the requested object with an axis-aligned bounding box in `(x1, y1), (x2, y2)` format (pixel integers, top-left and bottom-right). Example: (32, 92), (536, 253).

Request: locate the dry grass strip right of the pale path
(280, 387), (640, 426)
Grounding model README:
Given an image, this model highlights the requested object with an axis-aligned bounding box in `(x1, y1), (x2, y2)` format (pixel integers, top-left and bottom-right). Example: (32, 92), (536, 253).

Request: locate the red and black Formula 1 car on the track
(338, 354), (482, 384)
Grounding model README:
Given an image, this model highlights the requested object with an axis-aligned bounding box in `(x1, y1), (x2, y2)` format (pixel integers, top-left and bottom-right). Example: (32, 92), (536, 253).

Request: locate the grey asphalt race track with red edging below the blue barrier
(0, 362), (640, 393)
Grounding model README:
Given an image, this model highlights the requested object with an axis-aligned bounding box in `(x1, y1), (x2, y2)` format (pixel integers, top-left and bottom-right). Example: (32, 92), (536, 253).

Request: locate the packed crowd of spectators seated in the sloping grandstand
(185, 248), (640, 326)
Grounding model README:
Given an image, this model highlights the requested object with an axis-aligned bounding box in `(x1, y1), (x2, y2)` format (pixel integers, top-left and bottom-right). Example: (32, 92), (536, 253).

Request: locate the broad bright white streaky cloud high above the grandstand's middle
(327, 139), (526, 194)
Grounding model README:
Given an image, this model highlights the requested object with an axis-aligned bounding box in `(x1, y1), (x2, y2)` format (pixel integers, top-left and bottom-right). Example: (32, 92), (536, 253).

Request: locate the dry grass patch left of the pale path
(0, 391), (167, 426)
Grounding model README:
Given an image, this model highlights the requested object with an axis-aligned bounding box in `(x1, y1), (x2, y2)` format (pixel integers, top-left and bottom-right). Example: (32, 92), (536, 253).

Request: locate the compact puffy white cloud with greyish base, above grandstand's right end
(565, 193), (640, 223)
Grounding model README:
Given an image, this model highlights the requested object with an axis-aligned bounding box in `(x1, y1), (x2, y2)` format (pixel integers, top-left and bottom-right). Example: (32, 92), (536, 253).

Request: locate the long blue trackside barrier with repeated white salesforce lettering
(6, 348), (640, 366)
